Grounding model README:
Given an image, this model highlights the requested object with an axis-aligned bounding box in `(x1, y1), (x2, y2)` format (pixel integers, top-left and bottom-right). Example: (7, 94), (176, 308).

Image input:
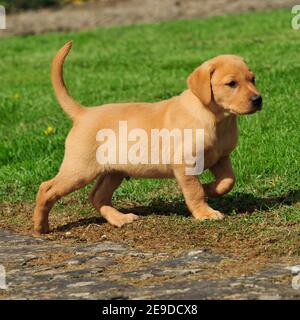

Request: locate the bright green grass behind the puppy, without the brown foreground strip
(0, 10), (300, 254)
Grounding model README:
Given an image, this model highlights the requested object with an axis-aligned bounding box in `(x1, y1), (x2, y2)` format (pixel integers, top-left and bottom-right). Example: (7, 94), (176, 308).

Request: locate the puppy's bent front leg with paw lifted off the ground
(203, 156), (235, 198)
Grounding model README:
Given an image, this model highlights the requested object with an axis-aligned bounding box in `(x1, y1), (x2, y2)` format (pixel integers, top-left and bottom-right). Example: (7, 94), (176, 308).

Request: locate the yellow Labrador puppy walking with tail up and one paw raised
(33, 42), (262, 234)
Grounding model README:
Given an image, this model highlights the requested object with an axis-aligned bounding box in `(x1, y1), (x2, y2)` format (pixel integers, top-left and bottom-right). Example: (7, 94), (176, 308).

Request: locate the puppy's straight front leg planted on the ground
(174, 169), (224, 220)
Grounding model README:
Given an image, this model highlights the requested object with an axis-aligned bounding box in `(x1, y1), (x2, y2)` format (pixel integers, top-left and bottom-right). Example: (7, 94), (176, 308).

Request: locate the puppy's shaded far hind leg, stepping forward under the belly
(89, 173), (138, 227)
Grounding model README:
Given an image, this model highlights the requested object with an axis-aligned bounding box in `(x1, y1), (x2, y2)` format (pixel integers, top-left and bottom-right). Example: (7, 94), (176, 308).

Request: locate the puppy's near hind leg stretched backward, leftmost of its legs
(33, 166), (96, 234)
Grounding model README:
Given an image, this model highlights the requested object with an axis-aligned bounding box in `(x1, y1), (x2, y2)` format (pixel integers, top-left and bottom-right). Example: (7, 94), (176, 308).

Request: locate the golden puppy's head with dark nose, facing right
(188, 55), (262, 114)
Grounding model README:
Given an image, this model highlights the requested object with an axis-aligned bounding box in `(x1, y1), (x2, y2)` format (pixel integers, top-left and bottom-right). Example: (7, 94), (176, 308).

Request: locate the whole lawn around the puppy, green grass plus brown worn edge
(0, 10), (300, 259)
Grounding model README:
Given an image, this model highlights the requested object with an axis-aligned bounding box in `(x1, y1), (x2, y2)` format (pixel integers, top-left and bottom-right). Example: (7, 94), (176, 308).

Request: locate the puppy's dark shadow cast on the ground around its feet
(55, 190), (300, 231)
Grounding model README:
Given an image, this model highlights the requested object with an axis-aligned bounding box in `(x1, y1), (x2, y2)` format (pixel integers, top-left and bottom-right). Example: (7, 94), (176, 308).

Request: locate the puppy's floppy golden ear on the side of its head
(187, 62), (214, 105)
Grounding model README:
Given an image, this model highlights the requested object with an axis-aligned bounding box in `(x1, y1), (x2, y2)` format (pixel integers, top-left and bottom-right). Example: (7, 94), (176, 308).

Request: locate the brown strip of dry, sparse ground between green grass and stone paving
(0, 200), (300, 261)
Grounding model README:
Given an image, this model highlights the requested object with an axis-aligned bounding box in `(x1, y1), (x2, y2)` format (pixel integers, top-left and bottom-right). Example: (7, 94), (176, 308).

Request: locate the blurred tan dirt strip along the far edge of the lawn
(0, 0), (295, 36)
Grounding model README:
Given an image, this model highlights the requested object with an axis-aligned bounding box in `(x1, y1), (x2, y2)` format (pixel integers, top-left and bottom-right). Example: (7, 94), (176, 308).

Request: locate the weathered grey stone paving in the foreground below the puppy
(0, 230), (300, 300)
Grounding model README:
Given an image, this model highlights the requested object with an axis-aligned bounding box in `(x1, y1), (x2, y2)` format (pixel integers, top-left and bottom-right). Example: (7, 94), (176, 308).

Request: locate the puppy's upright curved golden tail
(51, 41), (84, 120)
